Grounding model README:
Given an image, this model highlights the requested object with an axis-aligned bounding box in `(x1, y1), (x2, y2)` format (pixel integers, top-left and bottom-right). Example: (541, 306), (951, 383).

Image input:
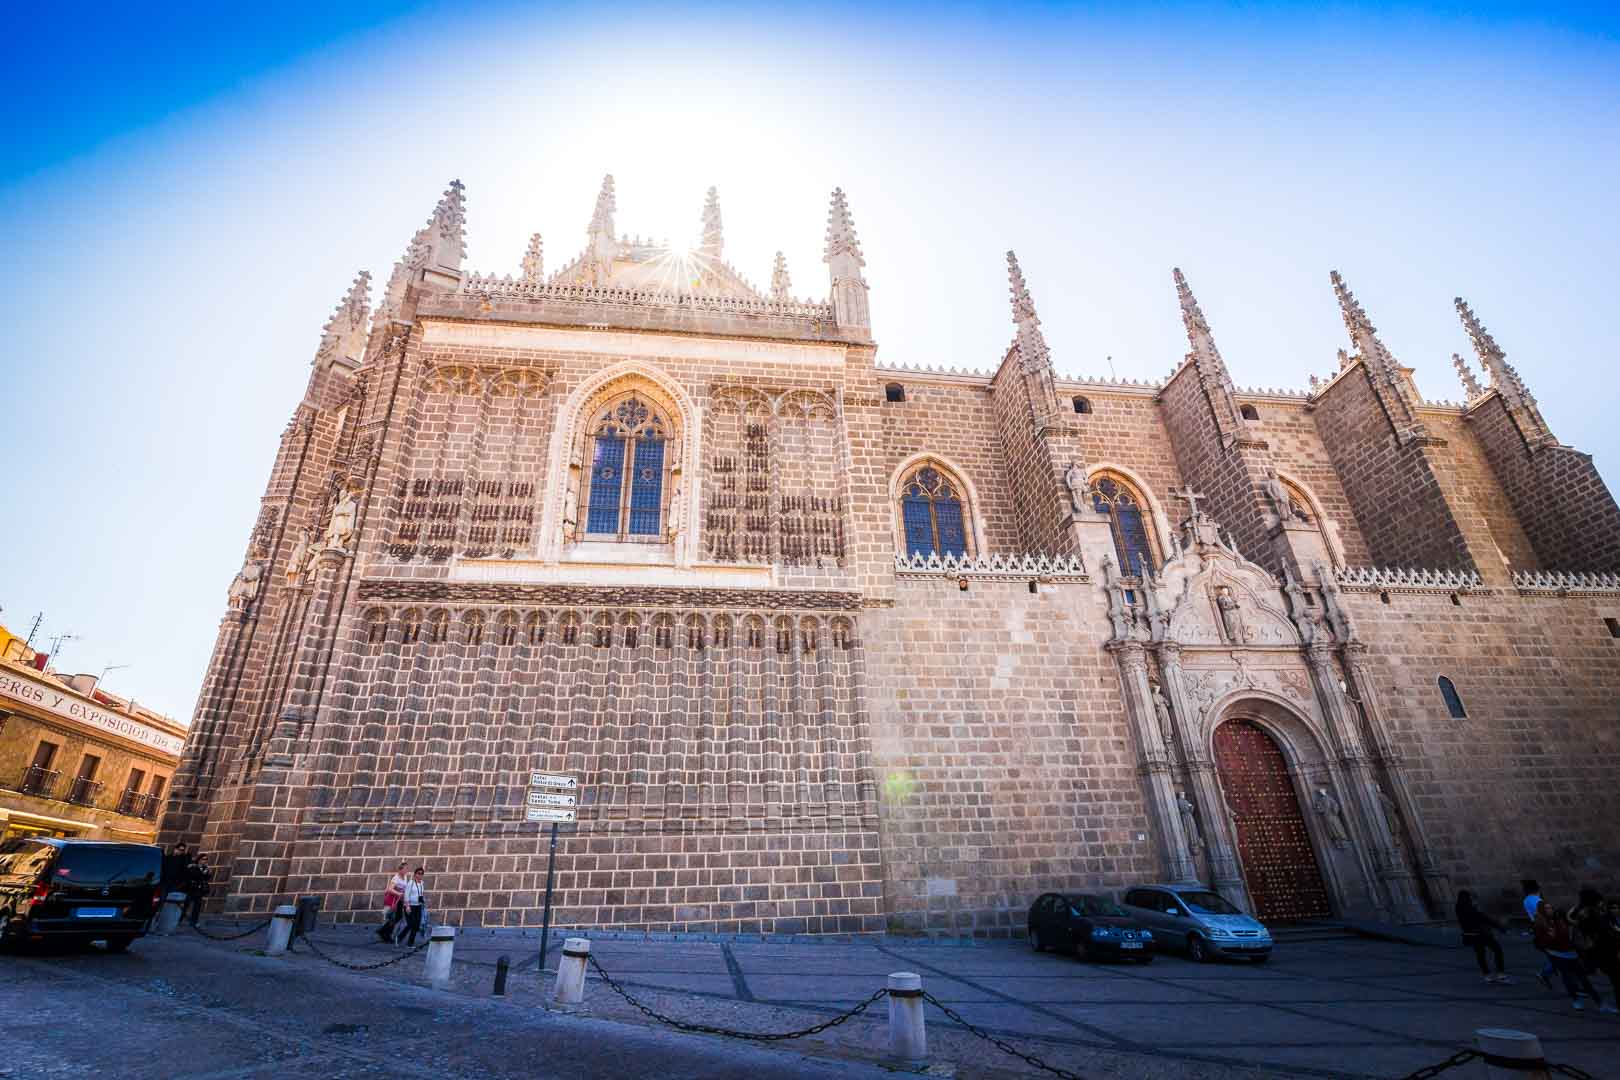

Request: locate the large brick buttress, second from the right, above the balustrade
(1315, 366), (1489, 570)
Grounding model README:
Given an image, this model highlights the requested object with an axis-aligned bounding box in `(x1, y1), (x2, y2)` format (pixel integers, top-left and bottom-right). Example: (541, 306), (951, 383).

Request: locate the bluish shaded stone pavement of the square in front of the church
(0, 928), (1620, 1080)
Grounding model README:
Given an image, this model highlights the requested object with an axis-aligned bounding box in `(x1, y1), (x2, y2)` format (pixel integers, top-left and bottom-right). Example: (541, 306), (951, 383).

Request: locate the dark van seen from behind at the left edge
(0, 837), (162, 952)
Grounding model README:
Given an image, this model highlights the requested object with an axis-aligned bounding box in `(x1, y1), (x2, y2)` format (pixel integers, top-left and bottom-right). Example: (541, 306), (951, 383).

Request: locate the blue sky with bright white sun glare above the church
(0, 3), (1620, 717)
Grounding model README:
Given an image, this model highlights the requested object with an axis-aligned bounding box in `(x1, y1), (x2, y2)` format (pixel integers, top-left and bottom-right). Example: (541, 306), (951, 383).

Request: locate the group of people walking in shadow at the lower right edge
(1456, 878), (1620, 1012)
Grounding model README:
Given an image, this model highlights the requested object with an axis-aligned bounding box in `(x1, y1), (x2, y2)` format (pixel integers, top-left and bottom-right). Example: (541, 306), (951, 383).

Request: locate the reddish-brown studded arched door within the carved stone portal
(1215, 721), (1332, 920)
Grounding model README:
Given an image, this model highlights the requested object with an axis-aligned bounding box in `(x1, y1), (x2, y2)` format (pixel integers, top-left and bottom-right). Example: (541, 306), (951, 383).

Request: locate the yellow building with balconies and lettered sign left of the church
(0, 650), (186, 842)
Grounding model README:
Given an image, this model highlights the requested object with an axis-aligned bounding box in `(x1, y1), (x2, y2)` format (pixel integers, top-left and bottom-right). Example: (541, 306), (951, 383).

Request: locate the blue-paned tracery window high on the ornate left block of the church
(582, 393), (669, 542)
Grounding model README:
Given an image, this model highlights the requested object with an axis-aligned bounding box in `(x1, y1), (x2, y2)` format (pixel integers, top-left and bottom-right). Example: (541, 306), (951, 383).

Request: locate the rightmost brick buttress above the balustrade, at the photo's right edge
(1469, 395), (1620, 572)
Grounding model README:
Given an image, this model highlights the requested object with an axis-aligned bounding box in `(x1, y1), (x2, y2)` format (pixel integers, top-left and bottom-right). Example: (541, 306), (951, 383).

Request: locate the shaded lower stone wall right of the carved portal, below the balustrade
(1345, 593), (1620, 907)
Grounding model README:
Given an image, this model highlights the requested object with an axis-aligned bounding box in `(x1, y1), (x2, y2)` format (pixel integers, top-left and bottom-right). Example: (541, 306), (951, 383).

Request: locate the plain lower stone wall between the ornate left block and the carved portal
(863, 580), (1158, 936)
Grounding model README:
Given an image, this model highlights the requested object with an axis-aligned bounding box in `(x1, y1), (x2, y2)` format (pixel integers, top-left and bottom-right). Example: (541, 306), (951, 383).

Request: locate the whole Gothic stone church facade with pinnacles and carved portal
(162, 178), (1620, 934)
